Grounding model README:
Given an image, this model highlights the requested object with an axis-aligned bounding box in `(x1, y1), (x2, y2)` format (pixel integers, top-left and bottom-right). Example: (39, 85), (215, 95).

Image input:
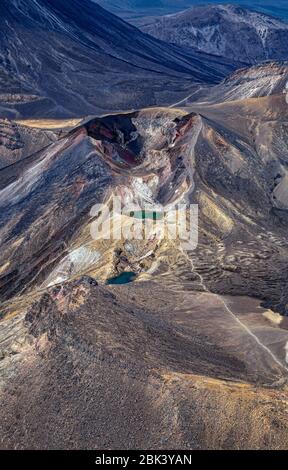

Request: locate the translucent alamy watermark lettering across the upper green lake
(90, 196), (198, 251)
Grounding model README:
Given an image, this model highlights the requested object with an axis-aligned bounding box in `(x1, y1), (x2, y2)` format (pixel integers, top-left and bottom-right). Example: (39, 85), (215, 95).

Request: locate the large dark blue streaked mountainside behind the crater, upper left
(0, 0), (235, 118)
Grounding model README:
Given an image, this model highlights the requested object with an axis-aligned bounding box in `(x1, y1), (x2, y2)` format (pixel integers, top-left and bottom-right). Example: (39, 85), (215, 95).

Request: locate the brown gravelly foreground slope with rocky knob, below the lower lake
(0, 276), (287, 451)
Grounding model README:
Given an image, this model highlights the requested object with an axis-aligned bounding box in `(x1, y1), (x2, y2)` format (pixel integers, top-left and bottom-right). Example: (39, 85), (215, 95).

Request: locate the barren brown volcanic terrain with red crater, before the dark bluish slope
(0, 59), (288, 449)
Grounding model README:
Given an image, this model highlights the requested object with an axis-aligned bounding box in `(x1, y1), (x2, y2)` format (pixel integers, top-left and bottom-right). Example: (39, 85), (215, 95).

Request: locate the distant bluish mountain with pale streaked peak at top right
(138, 5), (288, 64)
